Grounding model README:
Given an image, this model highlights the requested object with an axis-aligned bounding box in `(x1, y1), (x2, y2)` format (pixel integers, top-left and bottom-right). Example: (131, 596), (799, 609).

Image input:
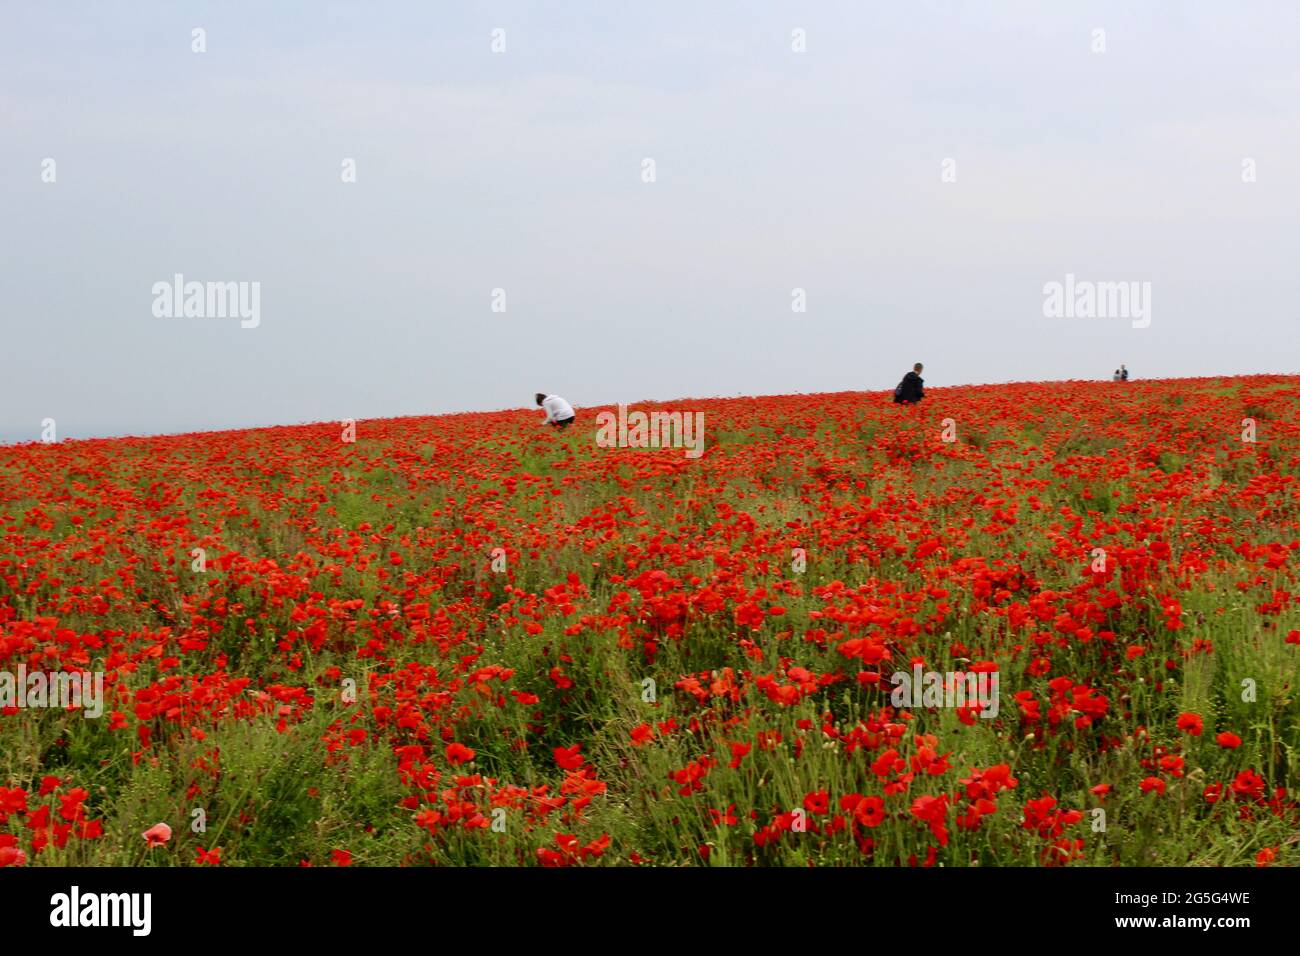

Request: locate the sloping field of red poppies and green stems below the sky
(0, 376), (1300, 868)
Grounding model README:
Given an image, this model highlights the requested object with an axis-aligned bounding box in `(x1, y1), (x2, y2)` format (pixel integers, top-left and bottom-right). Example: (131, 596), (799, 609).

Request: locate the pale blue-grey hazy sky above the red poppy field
(0, 0), (1300, 441)
